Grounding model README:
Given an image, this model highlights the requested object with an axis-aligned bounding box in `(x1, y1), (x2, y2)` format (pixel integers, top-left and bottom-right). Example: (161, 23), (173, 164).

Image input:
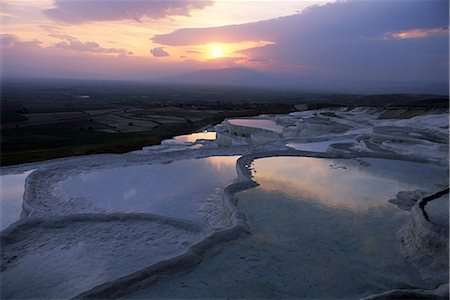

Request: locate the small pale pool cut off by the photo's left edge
(0, 171), (33, 230)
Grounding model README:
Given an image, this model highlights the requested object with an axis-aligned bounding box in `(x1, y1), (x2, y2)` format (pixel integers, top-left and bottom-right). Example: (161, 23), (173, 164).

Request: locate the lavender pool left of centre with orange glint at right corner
(57, 156), (238, 219)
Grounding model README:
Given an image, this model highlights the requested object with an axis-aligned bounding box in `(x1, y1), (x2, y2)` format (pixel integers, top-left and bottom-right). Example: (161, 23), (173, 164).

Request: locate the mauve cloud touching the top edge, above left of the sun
(44, 0), (212, 24)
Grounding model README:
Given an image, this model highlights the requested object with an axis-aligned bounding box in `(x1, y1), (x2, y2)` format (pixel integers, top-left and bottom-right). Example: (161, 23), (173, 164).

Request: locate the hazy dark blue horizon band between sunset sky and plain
(0, 69), (450, 96)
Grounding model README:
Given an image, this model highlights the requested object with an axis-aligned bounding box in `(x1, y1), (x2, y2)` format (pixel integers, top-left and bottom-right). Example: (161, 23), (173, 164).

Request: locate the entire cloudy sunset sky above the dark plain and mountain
(0, 0), (449, 89)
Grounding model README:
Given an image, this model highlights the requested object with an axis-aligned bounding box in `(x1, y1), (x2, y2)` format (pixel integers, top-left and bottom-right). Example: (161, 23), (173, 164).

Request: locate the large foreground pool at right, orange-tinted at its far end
(127, 157), (445, 299)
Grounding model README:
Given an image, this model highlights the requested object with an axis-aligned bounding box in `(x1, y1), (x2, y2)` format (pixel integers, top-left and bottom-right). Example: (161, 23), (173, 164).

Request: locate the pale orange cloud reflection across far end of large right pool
(253, 157), (447, 210)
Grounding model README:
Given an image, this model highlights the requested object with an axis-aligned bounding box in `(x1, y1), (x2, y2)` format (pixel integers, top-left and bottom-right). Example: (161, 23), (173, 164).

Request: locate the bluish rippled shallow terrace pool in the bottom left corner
(0, 217), (202, 299)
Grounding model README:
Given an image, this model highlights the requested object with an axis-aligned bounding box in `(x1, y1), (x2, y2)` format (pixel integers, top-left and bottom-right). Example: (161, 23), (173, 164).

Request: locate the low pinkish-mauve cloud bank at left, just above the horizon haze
(0, 34), (202, 80)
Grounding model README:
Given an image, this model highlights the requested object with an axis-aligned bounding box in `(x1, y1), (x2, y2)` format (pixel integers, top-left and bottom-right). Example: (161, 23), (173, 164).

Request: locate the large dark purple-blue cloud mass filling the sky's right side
(152, 0), (449, 81)
